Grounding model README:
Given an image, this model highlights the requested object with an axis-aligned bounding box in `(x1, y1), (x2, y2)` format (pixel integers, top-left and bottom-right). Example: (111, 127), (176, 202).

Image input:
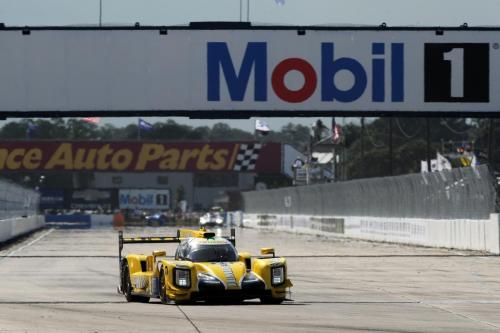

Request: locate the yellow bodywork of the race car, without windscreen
(122, 229), (292, 303)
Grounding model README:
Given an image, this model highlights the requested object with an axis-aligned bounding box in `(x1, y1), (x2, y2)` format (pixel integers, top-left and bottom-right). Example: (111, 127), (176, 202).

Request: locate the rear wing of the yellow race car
(118, 228), (236, 267)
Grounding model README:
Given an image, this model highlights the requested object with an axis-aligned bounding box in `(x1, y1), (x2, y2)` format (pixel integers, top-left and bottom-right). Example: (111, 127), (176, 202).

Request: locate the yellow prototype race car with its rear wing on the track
(118, 228), (292, 304)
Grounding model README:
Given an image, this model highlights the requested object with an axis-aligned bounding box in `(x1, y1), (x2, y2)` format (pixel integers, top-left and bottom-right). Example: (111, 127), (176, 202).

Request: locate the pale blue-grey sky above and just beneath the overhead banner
(0, 0), (500, 130)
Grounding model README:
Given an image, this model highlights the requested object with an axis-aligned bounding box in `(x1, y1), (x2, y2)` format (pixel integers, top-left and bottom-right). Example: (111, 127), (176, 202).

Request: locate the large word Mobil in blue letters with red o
(207, 42), (405, 103)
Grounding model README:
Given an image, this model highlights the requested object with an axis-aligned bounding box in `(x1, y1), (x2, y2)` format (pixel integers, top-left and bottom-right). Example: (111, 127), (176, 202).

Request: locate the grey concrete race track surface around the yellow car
(0, 228), (500, 333)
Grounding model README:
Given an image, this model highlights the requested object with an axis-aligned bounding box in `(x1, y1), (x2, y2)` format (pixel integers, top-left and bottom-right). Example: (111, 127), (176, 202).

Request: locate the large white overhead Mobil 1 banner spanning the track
(0, 27), (500, 115)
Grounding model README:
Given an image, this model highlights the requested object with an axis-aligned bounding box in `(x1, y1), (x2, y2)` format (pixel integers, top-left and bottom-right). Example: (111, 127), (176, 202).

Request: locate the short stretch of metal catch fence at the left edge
(0, 180), (40, 220)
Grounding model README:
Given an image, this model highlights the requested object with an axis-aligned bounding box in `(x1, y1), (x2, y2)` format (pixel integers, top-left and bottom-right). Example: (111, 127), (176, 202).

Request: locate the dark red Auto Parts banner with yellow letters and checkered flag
(0, 141), (281, 172)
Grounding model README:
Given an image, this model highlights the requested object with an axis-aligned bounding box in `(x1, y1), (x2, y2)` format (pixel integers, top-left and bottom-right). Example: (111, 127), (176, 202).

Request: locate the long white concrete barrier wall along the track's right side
(241, 213), (500, 254)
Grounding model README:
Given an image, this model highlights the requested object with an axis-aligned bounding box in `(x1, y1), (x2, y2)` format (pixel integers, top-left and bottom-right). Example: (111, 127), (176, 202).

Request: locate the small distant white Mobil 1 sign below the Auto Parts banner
(118, 189), (170, 210)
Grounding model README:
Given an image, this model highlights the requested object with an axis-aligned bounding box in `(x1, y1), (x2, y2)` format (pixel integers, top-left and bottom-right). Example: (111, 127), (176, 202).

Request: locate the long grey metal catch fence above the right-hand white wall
(243, 166), (496, 219)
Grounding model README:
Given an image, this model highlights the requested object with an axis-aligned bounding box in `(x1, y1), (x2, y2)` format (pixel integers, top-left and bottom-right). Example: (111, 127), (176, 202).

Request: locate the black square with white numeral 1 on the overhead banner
(425, 43), (490, 103)
